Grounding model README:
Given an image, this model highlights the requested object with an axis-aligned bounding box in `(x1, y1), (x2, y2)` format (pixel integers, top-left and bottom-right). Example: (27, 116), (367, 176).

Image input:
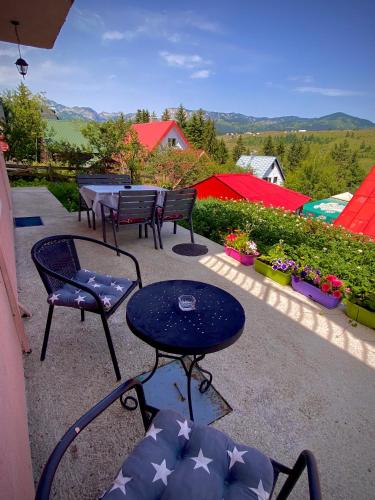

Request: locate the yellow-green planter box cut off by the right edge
(345, 286), (375, 329)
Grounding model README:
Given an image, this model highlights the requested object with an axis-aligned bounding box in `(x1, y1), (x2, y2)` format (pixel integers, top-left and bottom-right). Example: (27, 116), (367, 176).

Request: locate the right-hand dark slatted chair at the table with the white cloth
(156, 188), (197, 248)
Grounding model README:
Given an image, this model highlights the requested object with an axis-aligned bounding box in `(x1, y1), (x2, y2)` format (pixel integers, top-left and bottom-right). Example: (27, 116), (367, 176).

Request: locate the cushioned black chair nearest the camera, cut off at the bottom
(36, 380), (322, 500)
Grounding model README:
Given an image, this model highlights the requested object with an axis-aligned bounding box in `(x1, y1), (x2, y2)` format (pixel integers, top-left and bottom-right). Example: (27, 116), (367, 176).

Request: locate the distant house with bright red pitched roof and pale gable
(132, 120), (190, 151)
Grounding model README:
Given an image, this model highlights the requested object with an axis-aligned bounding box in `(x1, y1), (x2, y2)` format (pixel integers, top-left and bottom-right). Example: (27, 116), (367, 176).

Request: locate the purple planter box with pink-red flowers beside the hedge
(292, 266), (345, 309)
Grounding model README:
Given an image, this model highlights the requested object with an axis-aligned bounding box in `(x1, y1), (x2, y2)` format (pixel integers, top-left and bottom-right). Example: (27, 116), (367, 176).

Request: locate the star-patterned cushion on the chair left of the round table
(47, 269), (133, 311)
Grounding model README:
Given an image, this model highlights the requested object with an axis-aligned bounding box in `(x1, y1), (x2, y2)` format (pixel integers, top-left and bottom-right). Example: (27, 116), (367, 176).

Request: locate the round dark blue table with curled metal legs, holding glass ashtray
(126, 280), (245, 420)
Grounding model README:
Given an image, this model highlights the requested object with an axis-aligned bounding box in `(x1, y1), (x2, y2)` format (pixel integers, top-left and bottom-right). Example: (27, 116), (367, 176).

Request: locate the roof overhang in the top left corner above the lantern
(0, 0), (74, 49)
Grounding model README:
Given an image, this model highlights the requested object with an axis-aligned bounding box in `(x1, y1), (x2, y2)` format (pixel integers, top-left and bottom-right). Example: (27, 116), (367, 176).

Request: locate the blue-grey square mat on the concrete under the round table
(136, 358), (232, 425)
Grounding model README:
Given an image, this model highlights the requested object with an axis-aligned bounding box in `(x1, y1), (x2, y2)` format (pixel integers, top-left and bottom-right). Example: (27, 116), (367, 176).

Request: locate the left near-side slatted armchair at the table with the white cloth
(99, 189), (158, 250)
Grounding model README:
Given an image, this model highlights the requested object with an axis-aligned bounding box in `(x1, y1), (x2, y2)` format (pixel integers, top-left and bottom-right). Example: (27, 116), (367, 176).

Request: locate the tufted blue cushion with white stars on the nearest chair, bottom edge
(101, 410), (273, 500)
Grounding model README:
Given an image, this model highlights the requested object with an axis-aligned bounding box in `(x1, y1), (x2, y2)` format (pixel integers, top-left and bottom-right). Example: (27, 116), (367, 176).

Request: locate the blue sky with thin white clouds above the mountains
(0, 0), (375, 121)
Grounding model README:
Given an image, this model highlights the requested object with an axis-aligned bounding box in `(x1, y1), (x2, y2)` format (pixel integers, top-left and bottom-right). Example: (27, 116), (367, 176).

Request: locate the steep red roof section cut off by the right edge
(334, 165), (375, 239)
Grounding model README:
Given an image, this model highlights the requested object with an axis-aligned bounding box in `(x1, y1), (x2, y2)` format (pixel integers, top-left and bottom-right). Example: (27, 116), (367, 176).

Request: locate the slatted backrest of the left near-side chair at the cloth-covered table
(118, 189), (158, 221)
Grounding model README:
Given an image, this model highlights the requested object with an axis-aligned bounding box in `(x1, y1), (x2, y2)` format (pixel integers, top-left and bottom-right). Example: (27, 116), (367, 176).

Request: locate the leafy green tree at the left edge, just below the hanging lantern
(2, 83), (46, 161)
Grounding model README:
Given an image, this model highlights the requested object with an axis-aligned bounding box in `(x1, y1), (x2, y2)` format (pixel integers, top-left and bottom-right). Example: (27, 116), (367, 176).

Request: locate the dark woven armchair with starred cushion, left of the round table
(31, 235), (142, 380)
